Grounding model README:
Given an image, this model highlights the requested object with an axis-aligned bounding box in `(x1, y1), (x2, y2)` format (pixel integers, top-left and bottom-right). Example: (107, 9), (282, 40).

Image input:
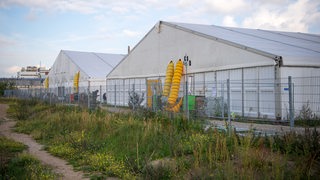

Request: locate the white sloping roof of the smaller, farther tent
(61, 50), (124, 78)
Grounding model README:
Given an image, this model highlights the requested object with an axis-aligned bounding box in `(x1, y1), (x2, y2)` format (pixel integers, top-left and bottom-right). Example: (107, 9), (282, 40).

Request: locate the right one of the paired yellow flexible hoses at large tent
(168, 59), (183, 107)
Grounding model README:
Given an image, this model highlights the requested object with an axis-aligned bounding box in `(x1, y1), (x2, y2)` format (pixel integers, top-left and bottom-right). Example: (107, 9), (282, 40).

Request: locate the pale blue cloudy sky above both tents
(0, 0), (320, 77)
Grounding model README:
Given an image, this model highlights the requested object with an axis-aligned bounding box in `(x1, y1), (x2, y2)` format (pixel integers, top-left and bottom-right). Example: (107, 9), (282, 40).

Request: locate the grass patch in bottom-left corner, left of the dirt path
(0, 136), (60, 179)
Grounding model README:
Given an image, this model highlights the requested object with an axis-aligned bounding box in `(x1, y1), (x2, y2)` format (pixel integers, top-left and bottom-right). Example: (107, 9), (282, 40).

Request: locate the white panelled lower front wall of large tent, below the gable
(107, 66), (275, 118)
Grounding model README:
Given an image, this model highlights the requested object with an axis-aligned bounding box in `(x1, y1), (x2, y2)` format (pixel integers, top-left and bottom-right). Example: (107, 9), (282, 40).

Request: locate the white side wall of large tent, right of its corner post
(281, 67), (320, 118)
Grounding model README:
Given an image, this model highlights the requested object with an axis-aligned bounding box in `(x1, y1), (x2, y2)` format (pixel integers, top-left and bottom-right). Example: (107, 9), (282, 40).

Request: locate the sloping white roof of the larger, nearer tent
(165, 22), (320, 67)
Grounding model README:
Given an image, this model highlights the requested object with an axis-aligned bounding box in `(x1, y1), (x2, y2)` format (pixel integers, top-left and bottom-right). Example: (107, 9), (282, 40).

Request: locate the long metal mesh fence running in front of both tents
(5, 77), (320, 126)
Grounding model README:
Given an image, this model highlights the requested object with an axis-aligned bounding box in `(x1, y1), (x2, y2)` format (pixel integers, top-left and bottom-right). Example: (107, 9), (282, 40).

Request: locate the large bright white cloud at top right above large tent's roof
(242, 0), (320, 32)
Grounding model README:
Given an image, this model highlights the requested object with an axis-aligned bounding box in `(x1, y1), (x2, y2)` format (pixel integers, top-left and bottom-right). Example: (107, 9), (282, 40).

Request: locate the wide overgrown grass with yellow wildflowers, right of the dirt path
(6, 99), (320, 179)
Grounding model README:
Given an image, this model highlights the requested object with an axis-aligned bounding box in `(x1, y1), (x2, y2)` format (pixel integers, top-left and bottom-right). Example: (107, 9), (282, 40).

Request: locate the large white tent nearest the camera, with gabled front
(107, 21), (320, 119)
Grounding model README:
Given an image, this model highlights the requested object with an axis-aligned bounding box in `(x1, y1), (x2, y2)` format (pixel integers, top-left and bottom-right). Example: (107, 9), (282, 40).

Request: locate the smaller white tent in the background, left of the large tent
(48, 50), (124, 94)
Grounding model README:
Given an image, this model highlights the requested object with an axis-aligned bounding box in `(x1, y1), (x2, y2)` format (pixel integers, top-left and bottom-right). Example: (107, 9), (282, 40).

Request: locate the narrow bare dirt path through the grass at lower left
(0, 104), (85, 180)
